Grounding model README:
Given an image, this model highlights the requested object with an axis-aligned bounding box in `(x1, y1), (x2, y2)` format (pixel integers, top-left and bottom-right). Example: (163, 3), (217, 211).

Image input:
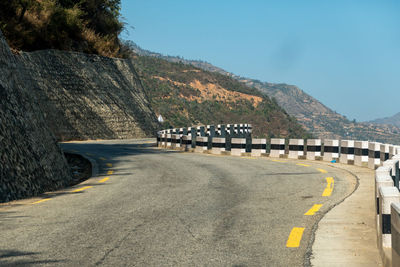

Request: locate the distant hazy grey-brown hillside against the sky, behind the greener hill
(130, 43), (400, 144)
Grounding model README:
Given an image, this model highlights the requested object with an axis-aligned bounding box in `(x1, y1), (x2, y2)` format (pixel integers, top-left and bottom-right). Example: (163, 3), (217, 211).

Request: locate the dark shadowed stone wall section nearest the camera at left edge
(0, 31), (72, 202)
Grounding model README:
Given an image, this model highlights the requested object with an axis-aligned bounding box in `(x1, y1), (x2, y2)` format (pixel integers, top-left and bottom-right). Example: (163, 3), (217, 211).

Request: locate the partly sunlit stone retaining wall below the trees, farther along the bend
(19, 50), (158, 140)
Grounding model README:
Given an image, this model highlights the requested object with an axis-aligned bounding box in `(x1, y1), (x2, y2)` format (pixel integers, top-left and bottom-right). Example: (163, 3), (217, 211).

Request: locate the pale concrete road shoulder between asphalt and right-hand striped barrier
(310, 164), (382, 267)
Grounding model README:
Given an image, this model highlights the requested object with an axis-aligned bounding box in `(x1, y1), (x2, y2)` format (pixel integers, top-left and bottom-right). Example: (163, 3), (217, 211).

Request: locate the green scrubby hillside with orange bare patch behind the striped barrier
(133, 53), (310, 137)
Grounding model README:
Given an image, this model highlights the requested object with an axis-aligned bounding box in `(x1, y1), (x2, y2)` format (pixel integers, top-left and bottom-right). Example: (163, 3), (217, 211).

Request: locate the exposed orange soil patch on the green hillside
(153, 76), (262, 107)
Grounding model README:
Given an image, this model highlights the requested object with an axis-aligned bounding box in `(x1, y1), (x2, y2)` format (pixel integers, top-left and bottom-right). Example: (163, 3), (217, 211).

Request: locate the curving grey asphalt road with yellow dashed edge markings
(0, 140), (355, 266)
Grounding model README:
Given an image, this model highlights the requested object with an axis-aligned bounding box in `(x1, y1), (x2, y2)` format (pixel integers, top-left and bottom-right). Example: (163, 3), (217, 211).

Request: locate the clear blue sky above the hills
(121, 0), (400, 121)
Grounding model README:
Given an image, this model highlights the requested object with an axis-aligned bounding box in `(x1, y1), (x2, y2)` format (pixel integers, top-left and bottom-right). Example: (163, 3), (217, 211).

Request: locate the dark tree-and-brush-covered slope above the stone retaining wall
(0, 0), (124, 57)
